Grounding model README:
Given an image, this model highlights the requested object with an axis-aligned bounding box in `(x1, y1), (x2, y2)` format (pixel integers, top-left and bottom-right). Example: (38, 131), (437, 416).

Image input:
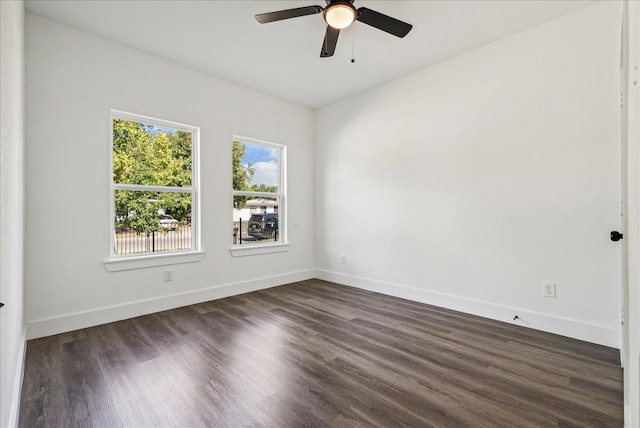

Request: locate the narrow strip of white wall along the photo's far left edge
(0, 1), (25, 427)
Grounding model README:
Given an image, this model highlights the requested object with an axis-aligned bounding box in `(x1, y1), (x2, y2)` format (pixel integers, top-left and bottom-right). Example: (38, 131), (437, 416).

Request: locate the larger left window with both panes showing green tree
(111, 112), (199, 256)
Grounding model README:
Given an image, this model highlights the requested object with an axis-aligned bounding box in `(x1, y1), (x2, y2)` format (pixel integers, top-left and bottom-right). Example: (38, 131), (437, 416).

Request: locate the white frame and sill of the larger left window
(104, 109), (204, 272)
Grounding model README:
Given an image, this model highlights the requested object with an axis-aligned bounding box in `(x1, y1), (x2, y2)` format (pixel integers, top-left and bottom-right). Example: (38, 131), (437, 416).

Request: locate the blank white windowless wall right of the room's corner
(316, 2), (622, 346)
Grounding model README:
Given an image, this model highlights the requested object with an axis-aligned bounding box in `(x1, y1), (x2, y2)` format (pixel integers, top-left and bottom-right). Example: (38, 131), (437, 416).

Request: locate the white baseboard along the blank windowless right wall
(316, 269), (620, 349)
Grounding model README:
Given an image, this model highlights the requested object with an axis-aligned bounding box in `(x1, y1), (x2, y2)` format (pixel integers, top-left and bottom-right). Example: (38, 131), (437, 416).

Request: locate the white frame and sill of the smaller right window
(229, 135), (290, 257)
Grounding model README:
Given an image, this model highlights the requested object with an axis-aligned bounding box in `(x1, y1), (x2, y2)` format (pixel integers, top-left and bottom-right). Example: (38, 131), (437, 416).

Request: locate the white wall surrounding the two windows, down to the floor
(25, 14), (314, 338)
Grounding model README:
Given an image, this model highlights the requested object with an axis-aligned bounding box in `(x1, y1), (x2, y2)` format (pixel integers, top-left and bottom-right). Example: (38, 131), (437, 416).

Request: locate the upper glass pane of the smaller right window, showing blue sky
(233, 141), (279, 193)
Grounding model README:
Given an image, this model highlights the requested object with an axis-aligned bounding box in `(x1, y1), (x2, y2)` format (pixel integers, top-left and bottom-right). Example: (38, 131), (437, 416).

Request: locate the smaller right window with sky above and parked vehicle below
(233, 137), (286, 245)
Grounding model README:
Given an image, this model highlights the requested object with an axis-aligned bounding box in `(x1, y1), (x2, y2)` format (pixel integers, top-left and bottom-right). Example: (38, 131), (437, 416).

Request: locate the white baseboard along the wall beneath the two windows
(27, 269), (315, 339)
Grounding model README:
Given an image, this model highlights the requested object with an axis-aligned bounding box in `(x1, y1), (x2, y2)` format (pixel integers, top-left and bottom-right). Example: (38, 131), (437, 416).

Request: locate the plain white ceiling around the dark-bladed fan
(26, 0), (596, 108)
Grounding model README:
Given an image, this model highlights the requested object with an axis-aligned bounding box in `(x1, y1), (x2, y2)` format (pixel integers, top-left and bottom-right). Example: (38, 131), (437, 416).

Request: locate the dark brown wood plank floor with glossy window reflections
(19, 280), (623, 428)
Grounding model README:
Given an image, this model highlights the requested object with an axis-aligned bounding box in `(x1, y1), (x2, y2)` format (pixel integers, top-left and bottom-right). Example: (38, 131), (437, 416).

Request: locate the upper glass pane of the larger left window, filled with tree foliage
(113, 118), (192, 187)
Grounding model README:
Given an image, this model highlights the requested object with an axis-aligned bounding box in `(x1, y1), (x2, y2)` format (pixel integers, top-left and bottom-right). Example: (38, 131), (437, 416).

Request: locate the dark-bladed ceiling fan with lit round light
(256, 0), (413, 58)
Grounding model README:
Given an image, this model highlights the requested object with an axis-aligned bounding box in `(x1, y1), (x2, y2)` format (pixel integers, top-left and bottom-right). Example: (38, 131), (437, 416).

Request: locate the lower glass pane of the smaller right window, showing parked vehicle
(233, 197), (280, 245)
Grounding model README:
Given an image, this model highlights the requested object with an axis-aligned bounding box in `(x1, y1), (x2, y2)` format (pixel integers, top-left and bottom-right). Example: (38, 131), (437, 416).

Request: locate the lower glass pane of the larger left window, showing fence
(114, 190), (192, 255)
